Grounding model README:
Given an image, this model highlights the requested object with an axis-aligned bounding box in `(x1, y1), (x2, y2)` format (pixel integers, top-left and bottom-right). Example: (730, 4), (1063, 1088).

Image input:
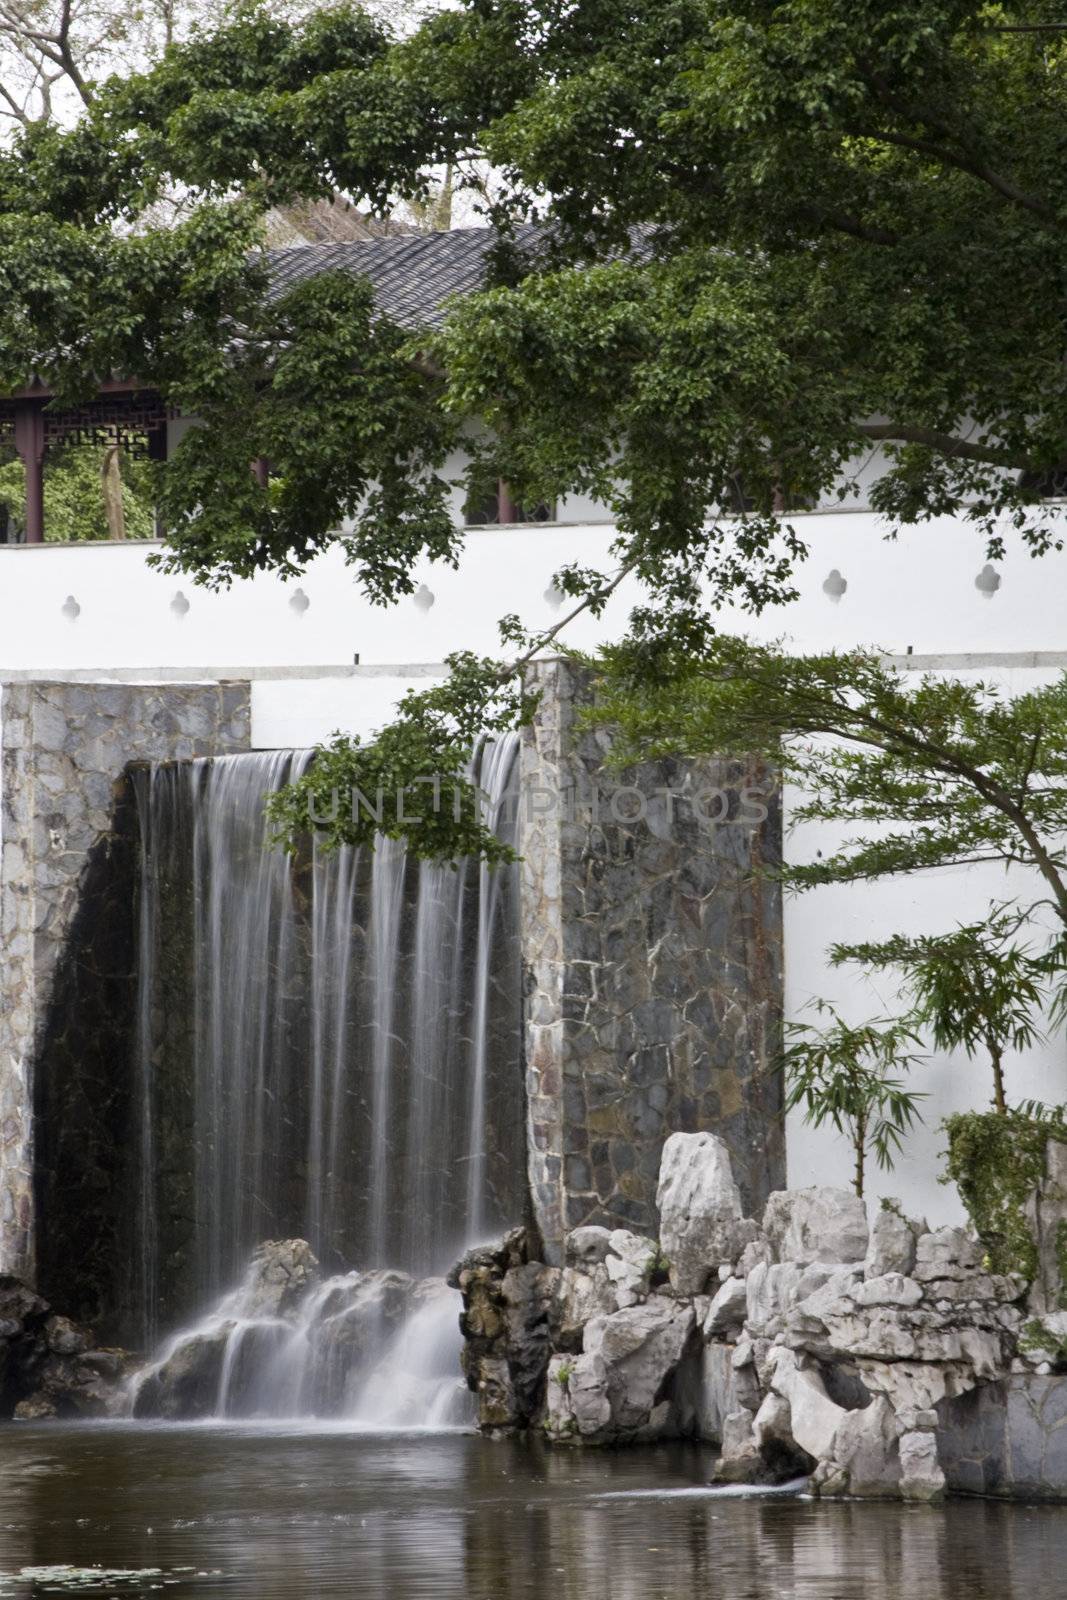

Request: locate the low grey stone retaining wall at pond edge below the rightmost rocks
(937, 1373), (1067, 1501)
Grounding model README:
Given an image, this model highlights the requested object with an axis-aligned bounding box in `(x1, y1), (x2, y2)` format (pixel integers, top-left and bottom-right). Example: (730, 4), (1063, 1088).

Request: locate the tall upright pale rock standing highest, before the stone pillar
(656, 1133), (758, 1294)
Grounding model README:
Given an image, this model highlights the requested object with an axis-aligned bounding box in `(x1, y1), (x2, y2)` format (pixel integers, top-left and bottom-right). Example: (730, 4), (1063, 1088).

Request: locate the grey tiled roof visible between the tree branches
(267, 227), (537, 326)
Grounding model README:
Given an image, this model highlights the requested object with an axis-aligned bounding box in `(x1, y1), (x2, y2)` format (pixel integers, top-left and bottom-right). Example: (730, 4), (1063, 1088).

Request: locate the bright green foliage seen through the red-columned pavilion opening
(0, 443), (155, 542)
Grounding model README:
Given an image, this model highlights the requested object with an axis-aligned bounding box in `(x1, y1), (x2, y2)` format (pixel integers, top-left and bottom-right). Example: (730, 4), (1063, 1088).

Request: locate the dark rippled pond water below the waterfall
(0, 1424), (1067, 1600)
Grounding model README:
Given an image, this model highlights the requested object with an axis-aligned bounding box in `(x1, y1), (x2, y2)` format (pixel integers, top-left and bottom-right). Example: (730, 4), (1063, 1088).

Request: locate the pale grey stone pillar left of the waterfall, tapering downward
(0, 682), (250, 1282)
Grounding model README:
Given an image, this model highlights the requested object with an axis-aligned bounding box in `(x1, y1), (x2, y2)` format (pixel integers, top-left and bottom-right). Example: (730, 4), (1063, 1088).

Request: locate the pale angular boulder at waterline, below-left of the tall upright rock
(576, 1296), (696, 1434)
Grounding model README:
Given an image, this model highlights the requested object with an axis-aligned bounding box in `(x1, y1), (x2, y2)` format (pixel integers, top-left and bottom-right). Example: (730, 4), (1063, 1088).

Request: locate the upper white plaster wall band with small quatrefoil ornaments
(0, 512), (1067, 675)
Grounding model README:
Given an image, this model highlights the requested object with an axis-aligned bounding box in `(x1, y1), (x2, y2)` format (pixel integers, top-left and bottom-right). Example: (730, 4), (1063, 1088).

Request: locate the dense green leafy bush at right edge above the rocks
(944, 1107), (1067, 1280)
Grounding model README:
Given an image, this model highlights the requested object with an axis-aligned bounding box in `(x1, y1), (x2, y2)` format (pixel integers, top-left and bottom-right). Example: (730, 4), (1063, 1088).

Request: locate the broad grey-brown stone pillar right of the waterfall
(518, 661), (785, 1261)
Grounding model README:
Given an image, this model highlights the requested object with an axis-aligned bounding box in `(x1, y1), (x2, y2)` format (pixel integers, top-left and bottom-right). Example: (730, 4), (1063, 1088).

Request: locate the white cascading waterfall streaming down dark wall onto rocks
(131, 736), (525, 1426)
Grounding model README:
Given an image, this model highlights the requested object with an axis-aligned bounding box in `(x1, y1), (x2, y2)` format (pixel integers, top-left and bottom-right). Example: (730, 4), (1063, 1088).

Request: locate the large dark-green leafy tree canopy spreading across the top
(0, 0), (1067, 857)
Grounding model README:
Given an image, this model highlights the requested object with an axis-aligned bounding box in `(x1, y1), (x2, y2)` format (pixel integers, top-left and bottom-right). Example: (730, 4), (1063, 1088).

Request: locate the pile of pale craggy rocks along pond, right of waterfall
(450, 1133), (1067, 1501)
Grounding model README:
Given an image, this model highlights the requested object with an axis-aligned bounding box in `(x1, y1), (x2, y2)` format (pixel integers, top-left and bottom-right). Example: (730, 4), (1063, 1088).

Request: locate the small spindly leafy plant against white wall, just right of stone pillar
(785, 1000), (926, 1197)
